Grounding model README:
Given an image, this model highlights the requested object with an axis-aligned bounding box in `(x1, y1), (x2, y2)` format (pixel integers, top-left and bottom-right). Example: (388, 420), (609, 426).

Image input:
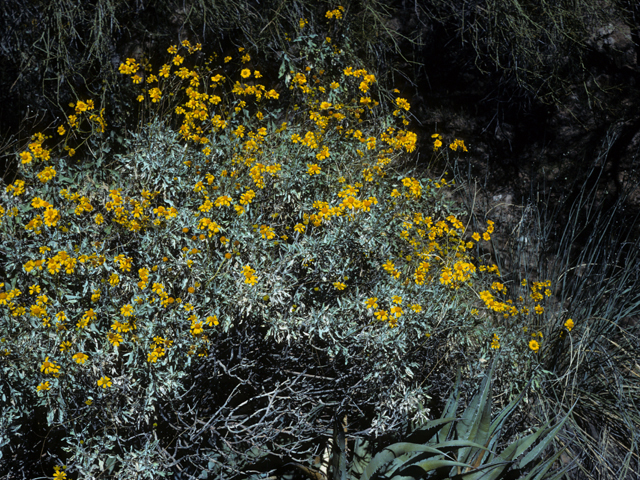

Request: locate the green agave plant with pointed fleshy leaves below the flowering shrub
(301, 362), (568, 480)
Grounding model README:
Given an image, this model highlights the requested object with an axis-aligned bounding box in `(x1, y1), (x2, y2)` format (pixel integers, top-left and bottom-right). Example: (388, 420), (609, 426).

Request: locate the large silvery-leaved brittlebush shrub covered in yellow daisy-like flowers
(0, 13), (564, 478)
